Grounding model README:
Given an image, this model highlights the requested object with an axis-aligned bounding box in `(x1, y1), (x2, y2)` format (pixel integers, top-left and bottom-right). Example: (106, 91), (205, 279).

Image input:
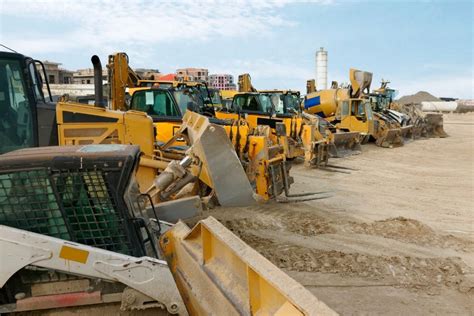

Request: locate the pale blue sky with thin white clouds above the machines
(0, 0), (474, 98)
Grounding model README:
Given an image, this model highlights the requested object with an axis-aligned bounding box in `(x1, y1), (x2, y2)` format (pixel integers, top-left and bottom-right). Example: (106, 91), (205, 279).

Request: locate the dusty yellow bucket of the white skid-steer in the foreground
(160, 217), (337, 315)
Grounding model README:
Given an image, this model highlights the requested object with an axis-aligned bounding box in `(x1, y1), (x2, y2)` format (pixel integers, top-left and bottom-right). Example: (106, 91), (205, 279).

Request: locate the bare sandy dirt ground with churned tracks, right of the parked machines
(201, 114), (474, 315)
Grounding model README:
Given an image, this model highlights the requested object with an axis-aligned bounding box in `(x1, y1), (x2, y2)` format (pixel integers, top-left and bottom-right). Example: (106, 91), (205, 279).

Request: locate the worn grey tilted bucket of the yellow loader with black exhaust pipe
(181, 111), (256, 207)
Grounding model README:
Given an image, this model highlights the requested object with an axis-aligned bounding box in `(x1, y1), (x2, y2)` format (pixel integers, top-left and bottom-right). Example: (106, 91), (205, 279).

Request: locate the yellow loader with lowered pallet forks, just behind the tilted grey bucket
(108, 53), (321, 202)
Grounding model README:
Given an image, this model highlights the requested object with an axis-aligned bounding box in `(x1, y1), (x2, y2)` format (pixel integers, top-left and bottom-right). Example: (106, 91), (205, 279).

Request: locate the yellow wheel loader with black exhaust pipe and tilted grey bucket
(0, 52), (255, 206)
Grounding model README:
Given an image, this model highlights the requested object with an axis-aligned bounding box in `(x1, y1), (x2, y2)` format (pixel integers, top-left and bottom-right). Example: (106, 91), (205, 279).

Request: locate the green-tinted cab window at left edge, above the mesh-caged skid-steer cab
(0, 59), (34, 154)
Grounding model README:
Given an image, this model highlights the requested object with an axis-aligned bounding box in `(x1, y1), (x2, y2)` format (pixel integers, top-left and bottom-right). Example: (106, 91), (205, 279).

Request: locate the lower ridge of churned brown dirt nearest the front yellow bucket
(235, 231), (469, 289)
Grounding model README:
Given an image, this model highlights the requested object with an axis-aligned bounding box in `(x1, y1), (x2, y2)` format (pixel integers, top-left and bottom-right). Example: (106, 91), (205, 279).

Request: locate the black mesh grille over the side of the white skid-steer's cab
(0, 168), (132, 254)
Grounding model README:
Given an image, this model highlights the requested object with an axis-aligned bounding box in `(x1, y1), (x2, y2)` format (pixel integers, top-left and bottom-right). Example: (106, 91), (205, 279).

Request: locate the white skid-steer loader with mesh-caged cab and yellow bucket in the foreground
(0, 145), (336, 315)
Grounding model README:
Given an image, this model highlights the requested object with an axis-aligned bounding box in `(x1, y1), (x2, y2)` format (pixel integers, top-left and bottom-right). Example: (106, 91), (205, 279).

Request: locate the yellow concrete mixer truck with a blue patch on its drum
(304, 69), (403, 148)
